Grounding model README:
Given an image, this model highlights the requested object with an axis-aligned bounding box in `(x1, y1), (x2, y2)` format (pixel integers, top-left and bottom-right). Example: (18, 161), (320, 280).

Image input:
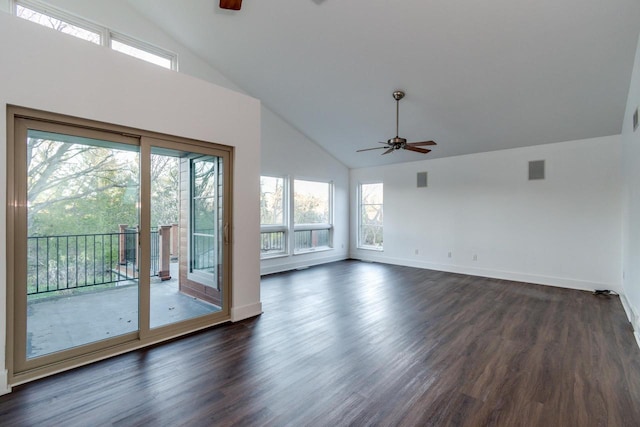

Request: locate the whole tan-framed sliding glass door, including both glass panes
(8, 109), (231, 379)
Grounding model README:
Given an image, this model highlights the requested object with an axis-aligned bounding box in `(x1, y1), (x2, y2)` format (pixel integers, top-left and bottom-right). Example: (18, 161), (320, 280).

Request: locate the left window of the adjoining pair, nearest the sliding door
(260, 176), (287, 258)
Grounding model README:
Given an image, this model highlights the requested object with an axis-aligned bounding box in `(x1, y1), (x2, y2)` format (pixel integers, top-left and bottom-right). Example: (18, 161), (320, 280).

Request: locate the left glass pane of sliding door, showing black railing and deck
(26, 130), (139, 358)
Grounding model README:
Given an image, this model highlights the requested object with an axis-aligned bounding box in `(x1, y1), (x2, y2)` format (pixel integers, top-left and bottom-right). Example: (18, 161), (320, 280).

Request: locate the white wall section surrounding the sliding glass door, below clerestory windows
(0, 13), (261, 393)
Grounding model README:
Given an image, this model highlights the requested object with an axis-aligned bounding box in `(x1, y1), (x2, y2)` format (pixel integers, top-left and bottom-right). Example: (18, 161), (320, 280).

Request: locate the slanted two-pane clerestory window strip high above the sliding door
(13, 0), (178, 70)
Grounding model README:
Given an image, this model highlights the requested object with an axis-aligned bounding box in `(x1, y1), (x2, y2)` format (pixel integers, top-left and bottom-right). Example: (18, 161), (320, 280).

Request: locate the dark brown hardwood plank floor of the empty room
(0, 261), (640, 427)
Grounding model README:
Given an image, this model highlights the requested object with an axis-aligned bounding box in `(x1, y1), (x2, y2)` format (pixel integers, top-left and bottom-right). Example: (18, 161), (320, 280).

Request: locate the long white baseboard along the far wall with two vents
(351, 254), (618, 291)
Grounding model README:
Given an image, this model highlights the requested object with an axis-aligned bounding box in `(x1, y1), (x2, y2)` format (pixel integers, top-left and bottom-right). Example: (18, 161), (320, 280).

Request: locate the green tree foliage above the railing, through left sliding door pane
(27, 138), (139, 235)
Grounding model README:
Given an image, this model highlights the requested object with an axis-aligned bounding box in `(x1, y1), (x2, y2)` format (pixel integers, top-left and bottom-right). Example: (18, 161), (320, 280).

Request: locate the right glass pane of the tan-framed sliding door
(150, 152), (222, 328)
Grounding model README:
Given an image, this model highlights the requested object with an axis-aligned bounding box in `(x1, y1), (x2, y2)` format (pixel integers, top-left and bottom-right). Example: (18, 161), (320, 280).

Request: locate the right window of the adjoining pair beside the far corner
(293, 179), (332, 253)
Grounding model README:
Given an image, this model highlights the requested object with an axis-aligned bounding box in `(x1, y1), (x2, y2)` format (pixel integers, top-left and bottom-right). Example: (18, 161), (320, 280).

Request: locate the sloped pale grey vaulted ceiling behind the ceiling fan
(128, 0), (640, 167)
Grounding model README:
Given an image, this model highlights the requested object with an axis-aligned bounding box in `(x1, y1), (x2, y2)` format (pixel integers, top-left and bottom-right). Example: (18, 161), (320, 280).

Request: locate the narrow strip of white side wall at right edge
(622, 32), (640, 345)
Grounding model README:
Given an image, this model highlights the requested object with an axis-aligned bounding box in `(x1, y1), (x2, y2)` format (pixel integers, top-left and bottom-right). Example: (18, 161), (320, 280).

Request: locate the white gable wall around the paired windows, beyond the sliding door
(260, 110), (349, 274)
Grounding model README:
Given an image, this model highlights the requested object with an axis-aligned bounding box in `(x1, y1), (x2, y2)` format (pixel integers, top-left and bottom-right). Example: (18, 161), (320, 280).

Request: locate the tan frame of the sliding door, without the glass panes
(6, 106), (234, 385)
